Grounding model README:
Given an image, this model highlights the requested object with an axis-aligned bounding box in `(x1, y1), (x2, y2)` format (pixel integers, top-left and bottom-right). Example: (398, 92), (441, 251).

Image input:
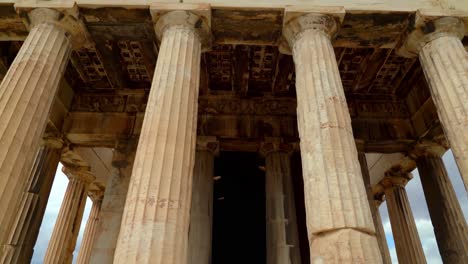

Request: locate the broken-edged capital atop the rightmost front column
(398, 10), (468, 57)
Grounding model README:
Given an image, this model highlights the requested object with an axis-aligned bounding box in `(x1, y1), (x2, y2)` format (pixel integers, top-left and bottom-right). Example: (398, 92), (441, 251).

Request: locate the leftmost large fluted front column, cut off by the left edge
(0, 9), (71, 244)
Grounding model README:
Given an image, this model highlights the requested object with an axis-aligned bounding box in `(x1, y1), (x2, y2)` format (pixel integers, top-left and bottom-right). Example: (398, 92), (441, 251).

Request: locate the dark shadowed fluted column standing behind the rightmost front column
(412, 144), (468, 263)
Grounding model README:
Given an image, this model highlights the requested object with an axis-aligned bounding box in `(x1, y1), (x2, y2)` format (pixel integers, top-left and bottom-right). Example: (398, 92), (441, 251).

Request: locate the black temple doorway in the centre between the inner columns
(212, 152), (266, 264)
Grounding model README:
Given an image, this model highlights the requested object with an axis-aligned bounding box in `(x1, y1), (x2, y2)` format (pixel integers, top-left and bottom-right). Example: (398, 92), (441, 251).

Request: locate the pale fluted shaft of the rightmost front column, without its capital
(419, 35), (468, 189)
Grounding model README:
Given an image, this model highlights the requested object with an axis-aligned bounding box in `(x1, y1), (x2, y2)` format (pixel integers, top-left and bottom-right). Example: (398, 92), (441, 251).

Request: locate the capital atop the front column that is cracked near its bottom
(280, 6), (345, 54)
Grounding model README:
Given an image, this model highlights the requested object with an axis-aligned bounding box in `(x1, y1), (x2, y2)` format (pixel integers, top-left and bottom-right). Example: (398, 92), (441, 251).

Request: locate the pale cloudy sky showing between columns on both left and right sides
(32, 151), (468, 264)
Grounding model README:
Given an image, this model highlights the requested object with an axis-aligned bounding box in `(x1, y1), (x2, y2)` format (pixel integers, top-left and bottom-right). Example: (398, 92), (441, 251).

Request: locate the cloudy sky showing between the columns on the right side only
(379, 151), (468, 264)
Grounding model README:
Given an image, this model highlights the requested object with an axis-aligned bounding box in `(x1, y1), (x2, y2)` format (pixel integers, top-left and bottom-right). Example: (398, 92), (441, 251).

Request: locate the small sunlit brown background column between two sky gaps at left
(44, 167), (94, 264)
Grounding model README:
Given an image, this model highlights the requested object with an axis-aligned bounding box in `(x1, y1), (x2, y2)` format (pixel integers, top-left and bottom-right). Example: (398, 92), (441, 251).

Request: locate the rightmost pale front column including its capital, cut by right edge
(400, 12), (468, 189)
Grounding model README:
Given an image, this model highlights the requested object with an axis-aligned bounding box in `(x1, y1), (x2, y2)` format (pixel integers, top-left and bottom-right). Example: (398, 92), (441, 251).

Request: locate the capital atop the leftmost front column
(15, 1), (92, 48)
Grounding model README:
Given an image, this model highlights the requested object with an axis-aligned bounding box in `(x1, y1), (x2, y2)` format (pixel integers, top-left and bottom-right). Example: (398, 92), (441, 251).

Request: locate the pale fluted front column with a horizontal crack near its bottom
(283, 8), (382, 263)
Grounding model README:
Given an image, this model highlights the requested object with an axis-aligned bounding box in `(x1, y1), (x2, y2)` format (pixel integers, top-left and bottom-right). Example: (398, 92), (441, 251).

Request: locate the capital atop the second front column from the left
(150, 3), (211, 51)
